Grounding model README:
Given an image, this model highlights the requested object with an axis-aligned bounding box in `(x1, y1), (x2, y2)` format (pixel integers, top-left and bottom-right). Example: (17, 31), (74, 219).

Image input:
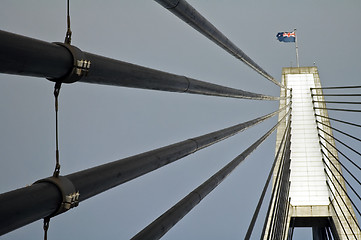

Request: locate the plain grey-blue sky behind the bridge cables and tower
(0, 0), (361, 240)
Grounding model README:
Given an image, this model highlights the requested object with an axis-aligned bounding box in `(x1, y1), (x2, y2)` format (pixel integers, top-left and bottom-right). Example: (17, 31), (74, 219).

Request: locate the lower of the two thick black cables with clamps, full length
(0, 106), (287, 235)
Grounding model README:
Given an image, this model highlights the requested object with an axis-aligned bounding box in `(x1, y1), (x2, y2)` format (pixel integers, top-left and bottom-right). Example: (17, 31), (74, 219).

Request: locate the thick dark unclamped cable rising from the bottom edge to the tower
(132, 110), (288, 240)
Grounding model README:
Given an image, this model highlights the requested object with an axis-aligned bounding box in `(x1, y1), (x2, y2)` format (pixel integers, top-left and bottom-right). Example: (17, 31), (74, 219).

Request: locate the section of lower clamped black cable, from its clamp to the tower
(68, 104), (285, 200)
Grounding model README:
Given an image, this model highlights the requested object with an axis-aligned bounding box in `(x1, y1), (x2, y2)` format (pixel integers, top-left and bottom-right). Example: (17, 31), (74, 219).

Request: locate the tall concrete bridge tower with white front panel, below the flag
(263, 67), (361, 240)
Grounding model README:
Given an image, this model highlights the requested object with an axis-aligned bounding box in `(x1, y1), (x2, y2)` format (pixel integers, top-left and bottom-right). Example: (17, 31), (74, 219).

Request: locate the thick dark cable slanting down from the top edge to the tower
(155, 0), (284, 87)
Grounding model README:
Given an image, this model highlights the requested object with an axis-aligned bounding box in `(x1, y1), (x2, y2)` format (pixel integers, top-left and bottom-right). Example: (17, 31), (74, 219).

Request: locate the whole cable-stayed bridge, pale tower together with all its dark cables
(0, 0), (361, 240)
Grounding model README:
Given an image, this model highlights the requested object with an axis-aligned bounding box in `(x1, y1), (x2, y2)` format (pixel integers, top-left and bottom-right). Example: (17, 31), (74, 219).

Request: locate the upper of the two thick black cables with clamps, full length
(0, 31), (280, 100)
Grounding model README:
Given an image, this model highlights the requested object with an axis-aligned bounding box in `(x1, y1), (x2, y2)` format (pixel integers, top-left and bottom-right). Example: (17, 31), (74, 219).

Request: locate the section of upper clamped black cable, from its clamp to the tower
(79, 52), (280, 100)
